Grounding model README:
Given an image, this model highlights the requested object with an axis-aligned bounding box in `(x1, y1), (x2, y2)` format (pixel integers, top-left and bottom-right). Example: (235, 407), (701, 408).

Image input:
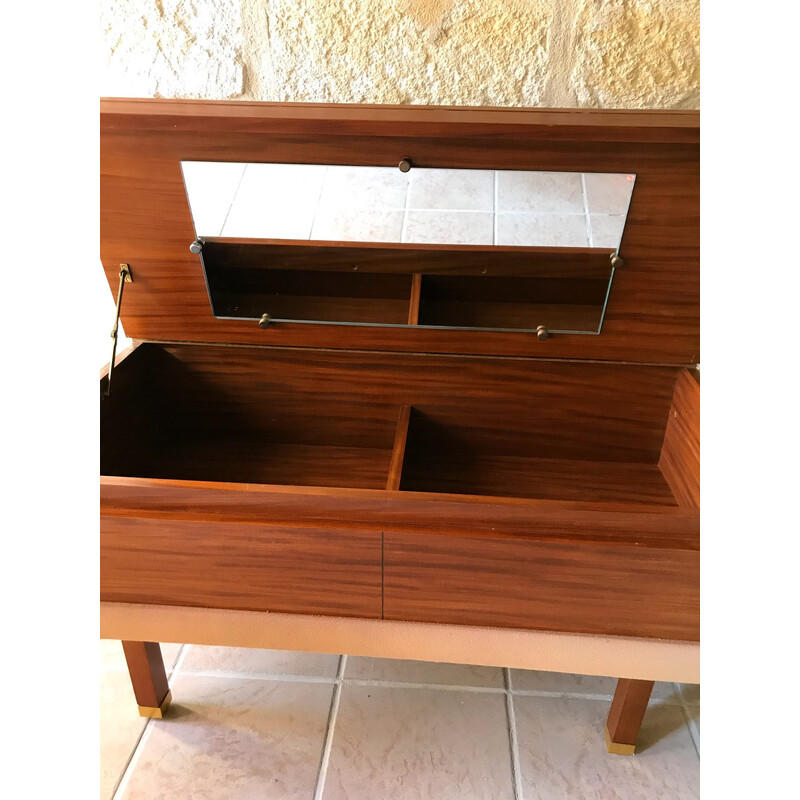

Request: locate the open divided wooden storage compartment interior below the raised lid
(101, 344), (692, 506)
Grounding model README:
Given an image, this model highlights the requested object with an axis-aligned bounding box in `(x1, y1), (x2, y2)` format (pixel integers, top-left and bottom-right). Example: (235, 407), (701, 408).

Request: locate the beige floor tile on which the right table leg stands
(514, 695), (700, 800)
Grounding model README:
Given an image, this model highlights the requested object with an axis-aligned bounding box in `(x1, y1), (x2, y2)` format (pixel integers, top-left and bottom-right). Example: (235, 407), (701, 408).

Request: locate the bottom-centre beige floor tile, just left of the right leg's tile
(323, 684), (514, 800)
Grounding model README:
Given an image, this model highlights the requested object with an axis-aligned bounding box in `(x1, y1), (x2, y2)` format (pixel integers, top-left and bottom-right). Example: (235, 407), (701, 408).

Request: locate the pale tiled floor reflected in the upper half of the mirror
(183, 162), (635, 248)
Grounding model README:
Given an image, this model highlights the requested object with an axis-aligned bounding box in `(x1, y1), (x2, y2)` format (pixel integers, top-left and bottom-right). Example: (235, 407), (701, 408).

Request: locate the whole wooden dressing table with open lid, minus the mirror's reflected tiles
(100, 99), (699, 753)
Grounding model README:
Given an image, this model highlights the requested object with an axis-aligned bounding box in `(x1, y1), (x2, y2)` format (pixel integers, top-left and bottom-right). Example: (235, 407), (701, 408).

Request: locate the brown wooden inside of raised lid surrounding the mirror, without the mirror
(100, 100), (699, 364)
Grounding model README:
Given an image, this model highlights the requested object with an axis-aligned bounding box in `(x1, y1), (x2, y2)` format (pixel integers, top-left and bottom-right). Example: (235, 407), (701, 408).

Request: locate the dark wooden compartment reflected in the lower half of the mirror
(202, 239), (613, 333)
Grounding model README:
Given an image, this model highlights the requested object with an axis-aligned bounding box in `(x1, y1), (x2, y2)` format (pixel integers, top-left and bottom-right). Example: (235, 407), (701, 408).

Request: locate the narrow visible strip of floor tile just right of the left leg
(181, 644), (339, 679)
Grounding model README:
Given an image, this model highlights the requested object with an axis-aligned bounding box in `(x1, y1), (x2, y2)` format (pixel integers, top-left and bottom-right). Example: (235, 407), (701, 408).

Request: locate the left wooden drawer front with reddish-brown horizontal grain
(100, 516), (381, 618)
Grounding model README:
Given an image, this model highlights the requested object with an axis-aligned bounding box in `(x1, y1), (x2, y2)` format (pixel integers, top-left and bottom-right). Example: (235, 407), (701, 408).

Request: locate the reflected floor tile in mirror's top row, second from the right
(497, 170), (584, 214)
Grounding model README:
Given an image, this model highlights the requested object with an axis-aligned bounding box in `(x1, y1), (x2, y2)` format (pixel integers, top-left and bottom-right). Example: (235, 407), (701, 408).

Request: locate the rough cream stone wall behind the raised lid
(101, 0), (700, 108)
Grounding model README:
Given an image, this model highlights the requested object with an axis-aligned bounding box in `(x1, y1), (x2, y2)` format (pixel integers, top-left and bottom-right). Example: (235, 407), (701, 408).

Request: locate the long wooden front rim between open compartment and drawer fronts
(100, 477), (700, 552)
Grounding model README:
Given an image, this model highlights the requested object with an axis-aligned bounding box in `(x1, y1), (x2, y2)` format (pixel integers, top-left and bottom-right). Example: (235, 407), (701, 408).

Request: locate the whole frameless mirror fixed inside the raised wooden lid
(182, 161), (635, 334)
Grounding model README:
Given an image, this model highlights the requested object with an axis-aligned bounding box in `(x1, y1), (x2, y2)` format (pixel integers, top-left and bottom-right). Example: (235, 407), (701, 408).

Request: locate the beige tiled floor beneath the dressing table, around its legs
(101, 641), (700, 800)
